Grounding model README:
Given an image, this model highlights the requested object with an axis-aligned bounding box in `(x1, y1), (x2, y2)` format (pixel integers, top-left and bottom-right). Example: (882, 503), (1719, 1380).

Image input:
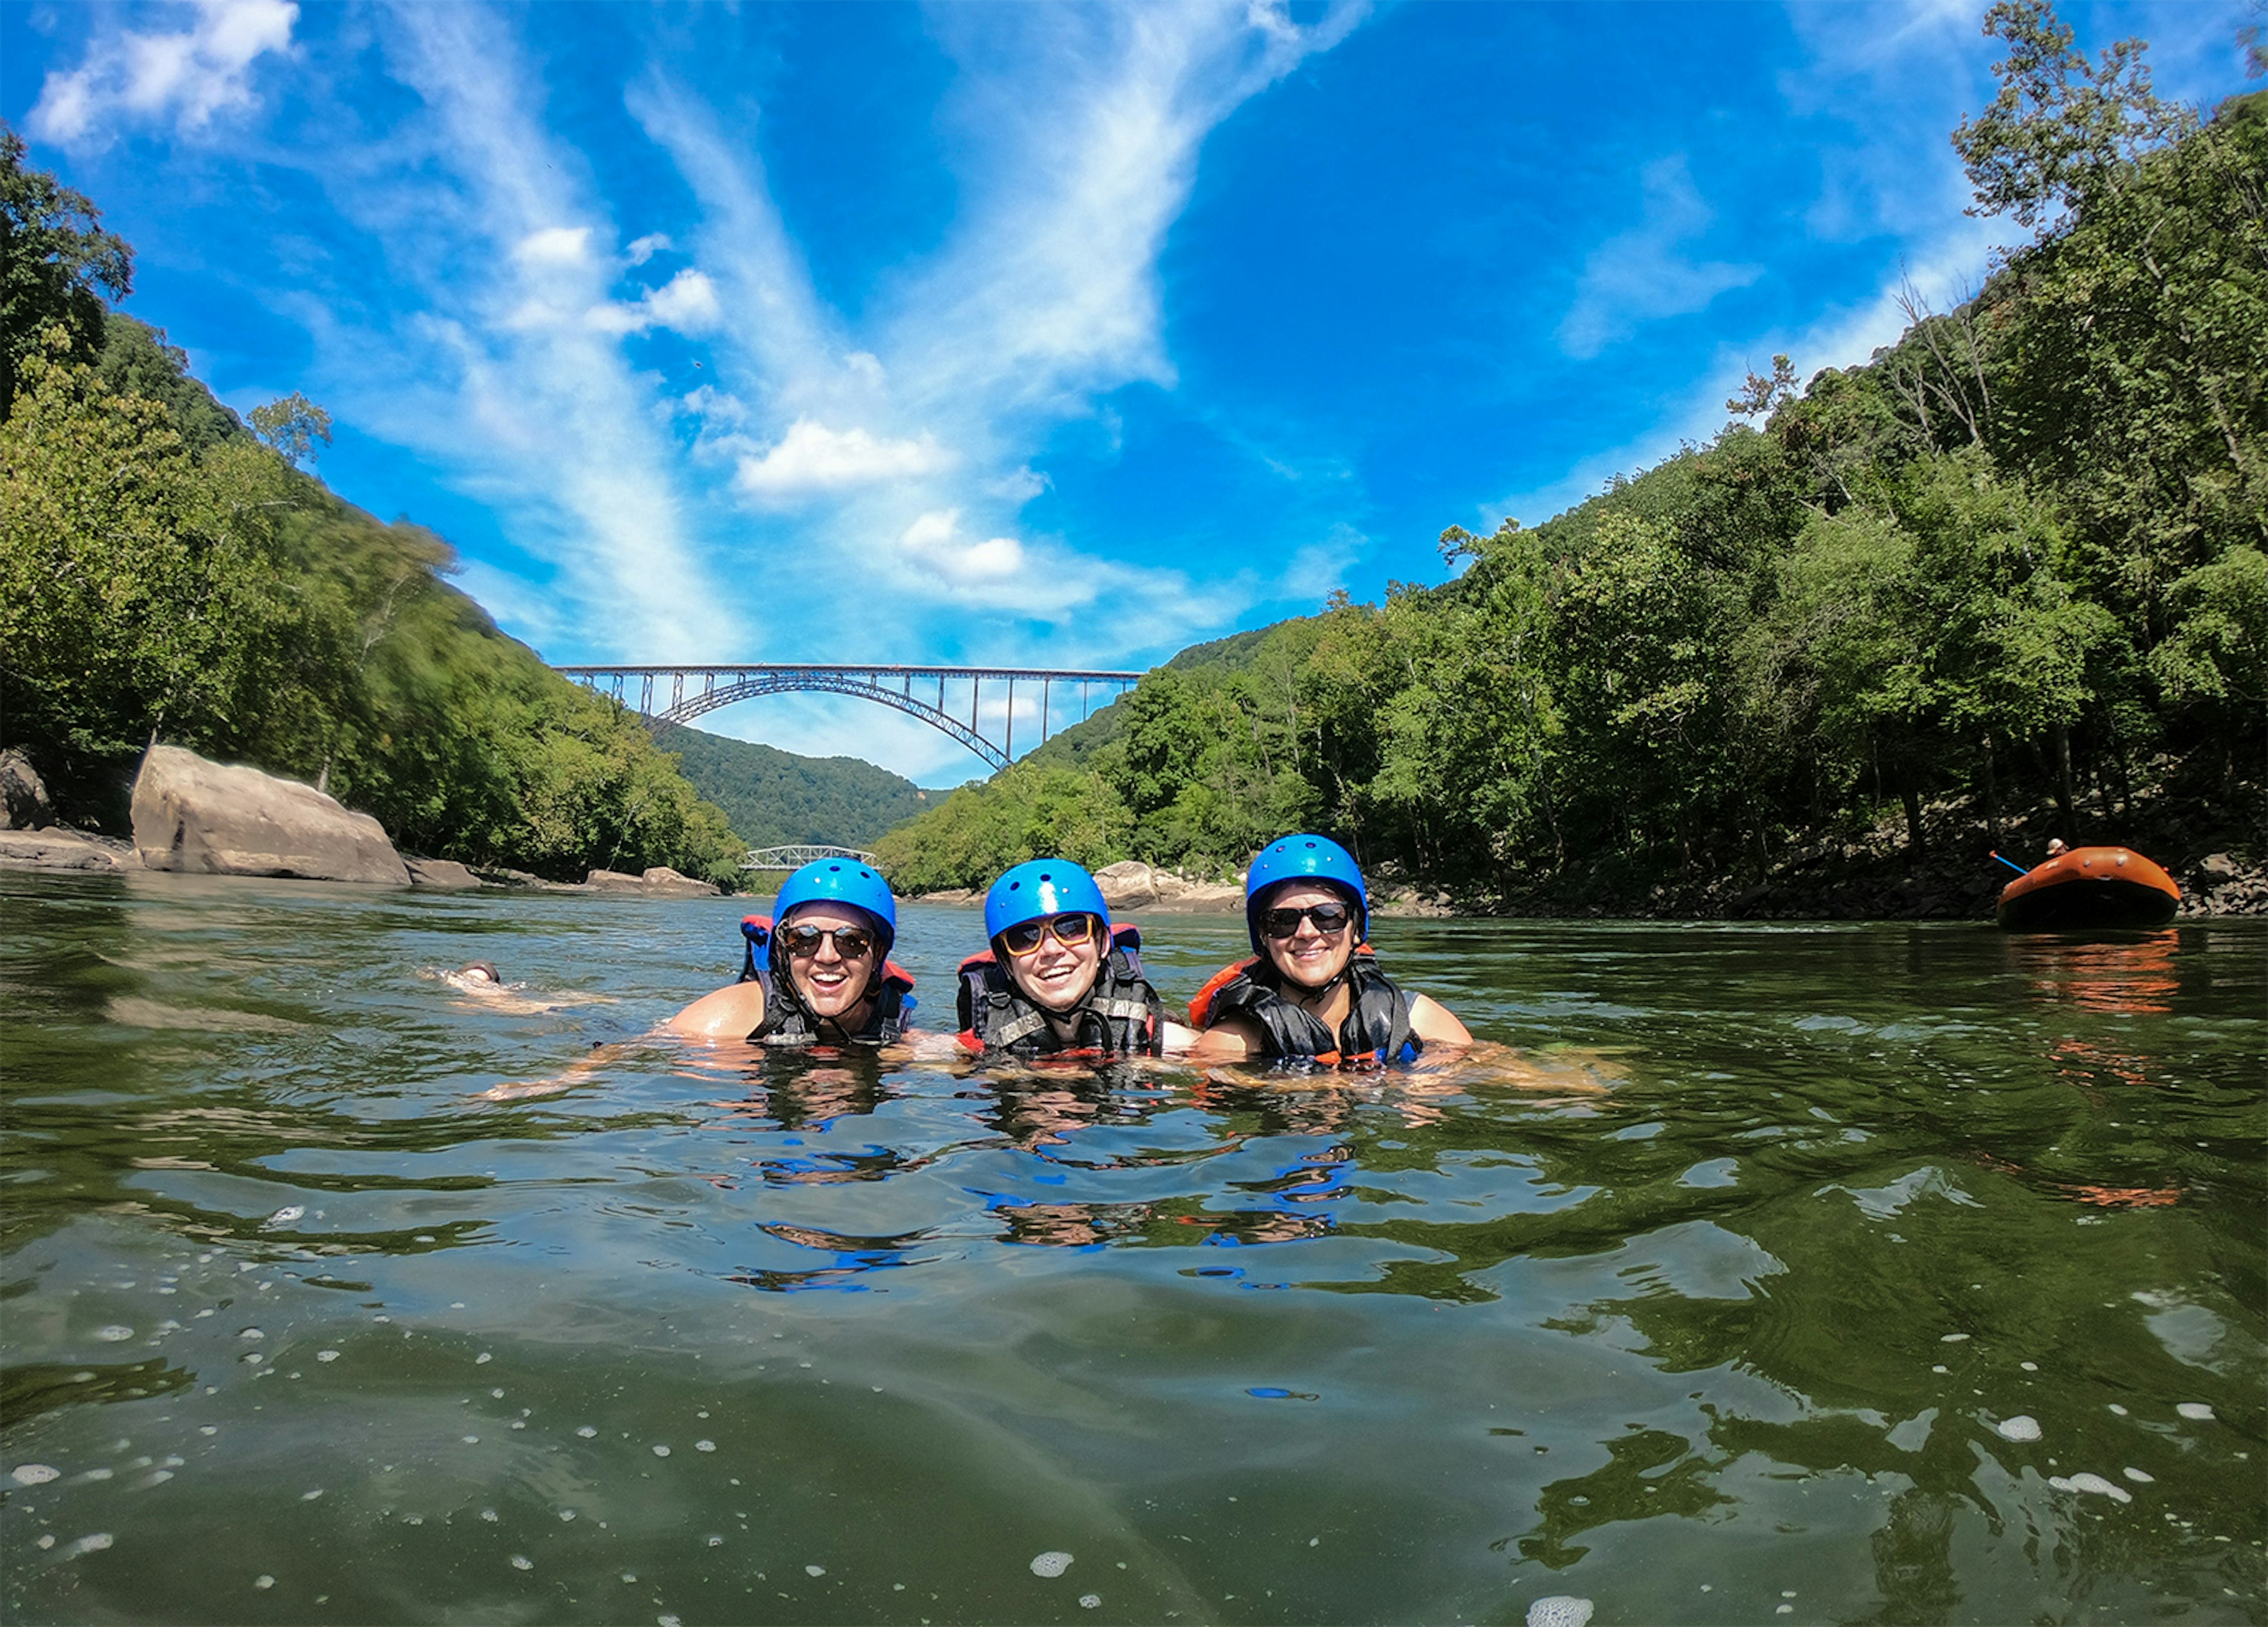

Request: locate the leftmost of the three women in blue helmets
(667, 857), (914, 1046)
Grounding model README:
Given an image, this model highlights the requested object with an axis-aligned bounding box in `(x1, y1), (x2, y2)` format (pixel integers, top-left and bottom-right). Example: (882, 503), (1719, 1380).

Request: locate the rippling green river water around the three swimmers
(0, 876), (2268, 1627)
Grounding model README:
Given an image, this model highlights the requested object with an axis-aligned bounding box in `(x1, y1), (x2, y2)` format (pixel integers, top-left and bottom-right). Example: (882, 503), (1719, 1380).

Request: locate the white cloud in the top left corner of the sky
(27, 0), (299, 145)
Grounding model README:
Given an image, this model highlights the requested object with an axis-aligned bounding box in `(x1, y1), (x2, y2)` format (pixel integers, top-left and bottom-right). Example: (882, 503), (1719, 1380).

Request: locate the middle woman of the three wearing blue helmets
(959, 857), (1195, 1058)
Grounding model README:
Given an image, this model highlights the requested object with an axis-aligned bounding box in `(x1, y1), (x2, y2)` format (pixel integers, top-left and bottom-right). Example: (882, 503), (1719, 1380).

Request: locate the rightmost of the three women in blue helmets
(1188, 835), (1472, 1067)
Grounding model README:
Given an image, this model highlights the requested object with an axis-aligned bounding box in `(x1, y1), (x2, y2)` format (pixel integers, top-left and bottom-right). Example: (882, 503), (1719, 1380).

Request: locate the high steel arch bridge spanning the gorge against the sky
(553, 663), (1141, 770)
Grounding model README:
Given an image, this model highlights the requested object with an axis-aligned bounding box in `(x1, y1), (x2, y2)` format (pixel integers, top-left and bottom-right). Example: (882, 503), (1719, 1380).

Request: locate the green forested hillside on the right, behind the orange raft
(880, 5), (2268, 908)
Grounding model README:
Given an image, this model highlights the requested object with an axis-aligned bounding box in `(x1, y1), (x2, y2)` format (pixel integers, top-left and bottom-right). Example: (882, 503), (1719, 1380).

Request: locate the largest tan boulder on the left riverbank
(134, 746), (410, 887)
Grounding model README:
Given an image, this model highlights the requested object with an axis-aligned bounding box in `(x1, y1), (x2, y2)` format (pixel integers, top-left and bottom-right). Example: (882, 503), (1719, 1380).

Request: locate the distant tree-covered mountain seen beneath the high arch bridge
(656, 724), (937, 849)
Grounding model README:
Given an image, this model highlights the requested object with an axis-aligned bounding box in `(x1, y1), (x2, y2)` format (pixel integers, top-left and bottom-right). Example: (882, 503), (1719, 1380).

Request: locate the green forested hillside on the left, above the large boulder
(0, 132), (739, 885)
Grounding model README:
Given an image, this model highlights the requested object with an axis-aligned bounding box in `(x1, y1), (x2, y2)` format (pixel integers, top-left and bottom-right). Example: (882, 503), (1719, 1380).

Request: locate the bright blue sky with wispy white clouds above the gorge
(0, 0), (2257, 783)
